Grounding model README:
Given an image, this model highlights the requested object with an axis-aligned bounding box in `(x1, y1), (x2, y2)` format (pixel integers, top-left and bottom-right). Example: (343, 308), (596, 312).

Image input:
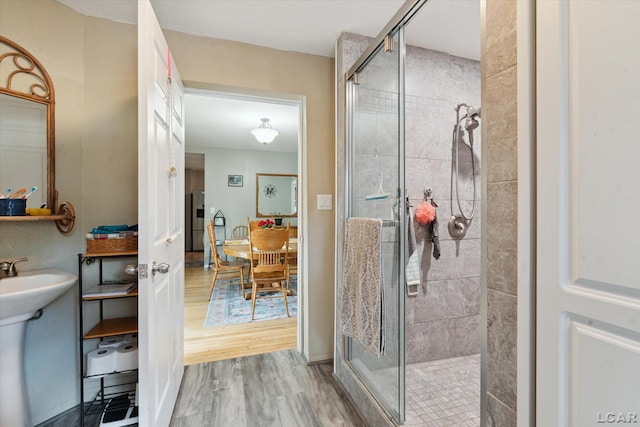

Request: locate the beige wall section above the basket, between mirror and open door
(82, 18), (138, 224)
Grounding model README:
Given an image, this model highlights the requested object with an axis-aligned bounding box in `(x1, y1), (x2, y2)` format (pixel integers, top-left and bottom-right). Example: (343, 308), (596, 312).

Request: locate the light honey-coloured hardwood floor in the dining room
(184, 267), (297, 365)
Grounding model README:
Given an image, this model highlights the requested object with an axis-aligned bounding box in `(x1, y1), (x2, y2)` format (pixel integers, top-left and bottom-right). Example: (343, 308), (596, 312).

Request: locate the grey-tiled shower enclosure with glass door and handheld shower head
(334, 0), (481, 426)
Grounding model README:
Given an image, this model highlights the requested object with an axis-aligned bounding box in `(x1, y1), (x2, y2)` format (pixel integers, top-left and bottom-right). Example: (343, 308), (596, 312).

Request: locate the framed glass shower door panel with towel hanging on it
(346, 30), (405, 424)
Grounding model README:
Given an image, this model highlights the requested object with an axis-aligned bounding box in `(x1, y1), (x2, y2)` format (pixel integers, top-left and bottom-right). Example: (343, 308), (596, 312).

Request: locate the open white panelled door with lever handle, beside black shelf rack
(138, 0), (184, 426)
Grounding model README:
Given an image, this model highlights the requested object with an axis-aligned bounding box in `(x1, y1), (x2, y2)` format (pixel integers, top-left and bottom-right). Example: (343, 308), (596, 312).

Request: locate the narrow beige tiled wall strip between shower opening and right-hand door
(482, 0), (518, 427)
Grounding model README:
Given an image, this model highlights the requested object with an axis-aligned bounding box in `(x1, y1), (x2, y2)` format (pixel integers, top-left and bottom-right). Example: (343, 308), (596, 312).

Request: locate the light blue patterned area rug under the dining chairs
(204, 278), (298, 327)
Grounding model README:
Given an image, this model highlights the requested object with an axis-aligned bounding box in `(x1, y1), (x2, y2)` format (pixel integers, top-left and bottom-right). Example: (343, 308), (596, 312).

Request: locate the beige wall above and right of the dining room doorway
(166, 31), (335, 361)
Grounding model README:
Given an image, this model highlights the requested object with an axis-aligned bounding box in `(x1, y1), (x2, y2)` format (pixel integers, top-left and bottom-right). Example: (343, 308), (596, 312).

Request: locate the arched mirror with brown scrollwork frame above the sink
(0, 36), (56, 210)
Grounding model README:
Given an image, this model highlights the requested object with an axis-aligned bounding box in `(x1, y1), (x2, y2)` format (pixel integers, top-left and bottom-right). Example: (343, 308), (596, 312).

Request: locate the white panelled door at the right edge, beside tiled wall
(536, 0), (640, 427)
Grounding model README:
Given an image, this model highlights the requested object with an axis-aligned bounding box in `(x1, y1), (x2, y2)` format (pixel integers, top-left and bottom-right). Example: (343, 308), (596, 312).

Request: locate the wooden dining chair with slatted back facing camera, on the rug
(249, 226), (290, 320)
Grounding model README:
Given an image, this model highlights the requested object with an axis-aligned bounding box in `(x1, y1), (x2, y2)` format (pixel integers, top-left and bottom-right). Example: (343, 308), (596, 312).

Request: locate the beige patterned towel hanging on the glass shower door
(340, 218), (384, 357)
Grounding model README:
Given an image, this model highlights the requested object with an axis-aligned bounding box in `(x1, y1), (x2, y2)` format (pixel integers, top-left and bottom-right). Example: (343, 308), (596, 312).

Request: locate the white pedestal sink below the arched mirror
(0, 268), (78, 426)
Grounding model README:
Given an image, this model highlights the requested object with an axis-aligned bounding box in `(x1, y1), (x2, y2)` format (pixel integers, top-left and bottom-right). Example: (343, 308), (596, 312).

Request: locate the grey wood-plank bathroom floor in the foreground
(169, 350), (365, 427)
